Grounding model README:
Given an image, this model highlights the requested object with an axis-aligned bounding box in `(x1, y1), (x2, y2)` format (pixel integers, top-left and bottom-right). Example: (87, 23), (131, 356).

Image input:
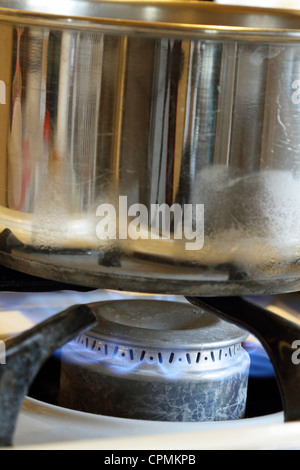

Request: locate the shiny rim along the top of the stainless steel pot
(0, 0), (300, 43)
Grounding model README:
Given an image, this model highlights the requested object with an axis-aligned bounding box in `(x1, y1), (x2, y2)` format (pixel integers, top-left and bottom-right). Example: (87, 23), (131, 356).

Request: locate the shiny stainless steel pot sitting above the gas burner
(0, 0), (300, 295)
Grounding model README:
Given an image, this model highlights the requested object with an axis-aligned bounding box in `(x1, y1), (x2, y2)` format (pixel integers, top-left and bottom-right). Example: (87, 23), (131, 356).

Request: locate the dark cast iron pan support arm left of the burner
(0, 305), (97, 447)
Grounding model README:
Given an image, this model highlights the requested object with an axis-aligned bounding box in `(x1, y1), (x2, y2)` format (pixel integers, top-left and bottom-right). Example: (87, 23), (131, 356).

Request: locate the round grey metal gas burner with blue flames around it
(59, 299), (250, 421)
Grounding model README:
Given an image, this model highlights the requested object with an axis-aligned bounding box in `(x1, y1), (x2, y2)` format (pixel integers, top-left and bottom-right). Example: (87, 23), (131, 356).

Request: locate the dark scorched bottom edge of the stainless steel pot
(0, 229), (300, 296)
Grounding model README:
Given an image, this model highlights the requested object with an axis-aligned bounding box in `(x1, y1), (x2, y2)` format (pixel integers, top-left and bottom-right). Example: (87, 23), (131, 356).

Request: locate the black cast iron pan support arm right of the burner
(187, 297), (300, 422)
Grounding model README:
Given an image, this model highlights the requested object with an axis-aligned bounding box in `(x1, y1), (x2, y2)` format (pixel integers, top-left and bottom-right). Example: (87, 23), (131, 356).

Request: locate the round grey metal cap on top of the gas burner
(88, 299), (248, 350)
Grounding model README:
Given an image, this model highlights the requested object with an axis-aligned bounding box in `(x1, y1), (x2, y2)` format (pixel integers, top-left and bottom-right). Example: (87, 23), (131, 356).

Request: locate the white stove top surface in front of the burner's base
(13, 398), (290, 450)
